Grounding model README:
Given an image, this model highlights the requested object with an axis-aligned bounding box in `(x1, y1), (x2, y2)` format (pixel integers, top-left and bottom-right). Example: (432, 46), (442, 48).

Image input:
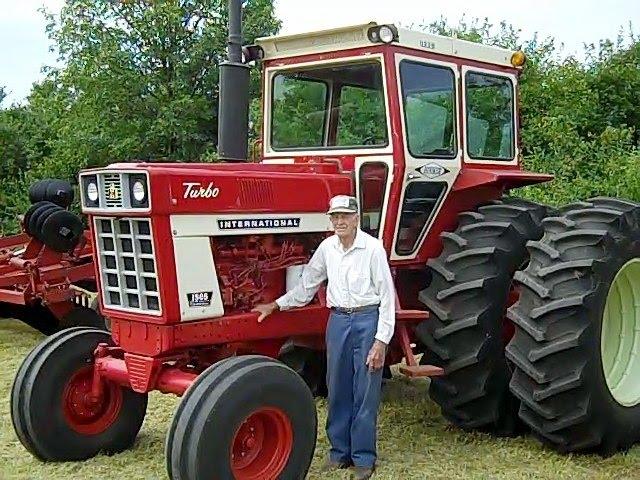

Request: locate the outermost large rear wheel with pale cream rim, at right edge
(507, 198), (640, 455)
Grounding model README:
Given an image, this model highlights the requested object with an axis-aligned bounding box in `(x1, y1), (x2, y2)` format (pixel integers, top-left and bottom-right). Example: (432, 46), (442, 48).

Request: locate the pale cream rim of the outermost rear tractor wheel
(600, 259), (640, 407)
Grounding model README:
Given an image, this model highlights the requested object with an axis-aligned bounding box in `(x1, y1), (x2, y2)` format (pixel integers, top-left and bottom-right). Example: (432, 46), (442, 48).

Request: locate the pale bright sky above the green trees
(0, 0), (640, 106)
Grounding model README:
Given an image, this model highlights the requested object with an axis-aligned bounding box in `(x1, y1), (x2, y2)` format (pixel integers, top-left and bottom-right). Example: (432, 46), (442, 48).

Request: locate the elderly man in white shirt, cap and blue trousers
(253, 195), (395, 480)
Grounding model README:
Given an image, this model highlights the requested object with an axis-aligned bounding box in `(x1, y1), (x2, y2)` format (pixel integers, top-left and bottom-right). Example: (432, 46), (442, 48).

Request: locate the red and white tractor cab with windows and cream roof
(252, 23), (546, 263)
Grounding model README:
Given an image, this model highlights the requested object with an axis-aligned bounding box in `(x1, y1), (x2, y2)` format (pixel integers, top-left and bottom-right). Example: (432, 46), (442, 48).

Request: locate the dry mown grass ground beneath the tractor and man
(0, 320), (640, 480)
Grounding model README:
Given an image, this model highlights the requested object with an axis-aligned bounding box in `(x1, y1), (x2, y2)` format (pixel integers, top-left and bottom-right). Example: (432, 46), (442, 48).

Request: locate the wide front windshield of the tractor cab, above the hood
(271, 61), (388, 150)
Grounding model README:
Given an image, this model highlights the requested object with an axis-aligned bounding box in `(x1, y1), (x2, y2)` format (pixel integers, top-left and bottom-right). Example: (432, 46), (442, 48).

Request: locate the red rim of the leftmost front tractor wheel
(62, 365), (122, 435)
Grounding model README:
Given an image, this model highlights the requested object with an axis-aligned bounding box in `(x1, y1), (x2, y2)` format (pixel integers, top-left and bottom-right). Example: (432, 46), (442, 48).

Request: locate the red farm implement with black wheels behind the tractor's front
(0, 179), (105, 335)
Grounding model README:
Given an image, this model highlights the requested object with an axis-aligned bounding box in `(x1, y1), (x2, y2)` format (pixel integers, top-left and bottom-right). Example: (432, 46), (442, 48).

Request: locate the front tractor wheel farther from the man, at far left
(11, 327), (147, 461)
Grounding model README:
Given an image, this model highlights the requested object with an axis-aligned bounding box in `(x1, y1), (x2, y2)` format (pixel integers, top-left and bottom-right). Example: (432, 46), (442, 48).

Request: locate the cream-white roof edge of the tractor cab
(256, 22), (515, 67)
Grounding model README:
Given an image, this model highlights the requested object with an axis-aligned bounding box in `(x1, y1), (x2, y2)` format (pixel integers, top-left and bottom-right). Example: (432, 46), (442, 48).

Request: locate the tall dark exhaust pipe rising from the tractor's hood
(218, 0), (249, 162)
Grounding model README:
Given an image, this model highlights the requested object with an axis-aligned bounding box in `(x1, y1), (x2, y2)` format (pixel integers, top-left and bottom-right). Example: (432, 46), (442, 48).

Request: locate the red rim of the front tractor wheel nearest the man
(231, 407), (293, 480)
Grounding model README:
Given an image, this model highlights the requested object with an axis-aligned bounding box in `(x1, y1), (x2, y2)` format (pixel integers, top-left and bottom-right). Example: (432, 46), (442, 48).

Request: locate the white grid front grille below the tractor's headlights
(95, 217), (161, 315)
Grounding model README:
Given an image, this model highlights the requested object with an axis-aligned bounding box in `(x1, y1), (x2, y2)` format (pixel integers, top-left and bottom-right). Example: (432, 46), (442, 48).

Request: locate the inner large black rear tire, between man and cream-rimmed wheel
(416, 198), (546, 435)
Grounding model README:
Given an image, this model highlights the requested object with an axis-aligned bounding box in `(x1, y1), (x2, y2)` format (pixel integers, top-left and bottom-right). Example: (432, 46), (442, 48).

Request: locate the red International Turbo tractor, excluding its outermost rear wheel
(11, 0), (632, 480)
